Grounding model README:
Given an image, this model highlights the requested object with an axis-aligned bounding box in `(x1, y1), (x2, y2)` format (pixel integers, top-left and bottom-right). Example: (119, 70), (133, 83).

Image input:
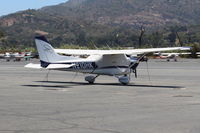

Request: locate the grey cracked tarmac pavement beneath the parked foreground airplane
(0, 59), (200, 133)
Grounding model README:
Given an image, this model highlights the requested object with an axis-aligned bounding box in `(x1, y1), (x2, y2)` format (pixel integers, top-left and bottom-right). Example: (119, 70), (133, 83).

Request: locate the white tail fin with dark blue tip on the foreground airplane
(35, 36), (67, 67)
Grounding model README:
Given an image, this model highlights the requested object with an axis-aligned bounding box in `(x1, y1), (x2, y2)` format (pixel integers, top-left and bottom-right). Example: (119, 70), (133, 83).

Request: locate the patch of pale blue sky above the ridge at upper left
(0, 0), (68, 16)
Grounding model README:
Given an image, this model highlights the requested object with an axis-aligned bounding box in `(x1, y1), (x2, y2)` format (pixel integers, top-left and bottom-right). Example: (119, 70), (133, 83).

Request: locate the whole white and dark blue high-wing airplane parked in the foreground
(25, 36), (190, 84)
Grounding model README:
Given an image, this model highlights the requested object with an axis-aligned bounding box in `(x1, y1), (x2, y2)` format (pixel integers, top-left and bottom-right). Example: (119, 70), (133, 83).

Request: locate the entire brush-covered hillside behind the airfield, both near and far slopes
(0, 0), (200, 48)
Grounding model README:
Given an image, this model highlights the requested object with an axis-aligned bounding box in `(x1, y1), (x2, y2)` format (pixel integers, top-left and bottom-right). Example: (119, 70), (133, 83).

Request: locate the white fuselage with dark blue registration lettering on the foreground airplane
(41, 55), (136, 76)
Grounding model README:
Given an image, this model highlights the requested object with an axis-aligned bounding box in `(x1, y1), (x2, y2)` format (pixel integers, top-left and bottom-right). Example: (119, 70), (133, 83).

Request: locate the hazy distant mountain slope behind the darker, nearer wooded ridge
(41, 0), (200, 27)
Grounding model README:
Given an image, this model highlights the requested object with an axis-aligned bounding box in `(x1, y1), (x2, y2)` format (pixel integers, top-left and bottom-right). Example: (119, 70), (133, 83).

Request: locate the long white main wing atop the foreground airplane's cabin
(54, 47), (190, 55)
